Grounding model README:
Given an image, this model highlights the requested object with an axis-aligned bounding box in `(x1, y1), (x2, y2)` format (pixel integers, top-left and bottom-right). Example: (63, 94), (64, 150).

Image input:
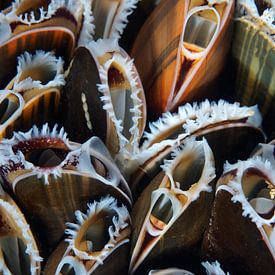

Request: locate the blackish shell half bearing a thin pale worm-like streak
(59, 47), (107, 142)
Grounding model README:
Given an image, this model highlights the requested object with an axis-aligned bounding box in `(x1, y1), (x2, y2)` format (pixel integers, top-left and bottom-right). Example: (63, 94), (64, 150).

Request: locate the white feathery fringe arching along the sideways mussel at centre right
(142, 100), (262, 150)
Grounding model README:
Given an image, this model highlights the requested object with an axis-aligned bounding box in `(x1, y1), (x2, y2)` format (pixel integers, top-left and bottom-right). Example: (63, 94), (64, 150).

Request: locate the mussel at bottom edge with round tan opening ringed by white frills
(45, 197), (131, 275)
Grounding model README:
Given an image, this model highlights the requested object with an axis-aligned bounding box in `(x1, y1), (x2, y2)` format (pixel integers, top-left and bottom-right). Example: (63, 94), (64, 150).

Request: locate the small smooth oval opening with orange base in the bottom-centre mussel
(150, 194), (173, 230)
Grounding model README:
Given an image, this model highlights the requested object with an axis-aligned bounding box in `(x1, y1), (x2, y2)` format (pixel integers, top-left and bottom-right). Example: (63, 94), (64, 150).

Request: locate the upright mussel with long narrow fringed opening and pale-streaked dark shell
(61, 39), (146, 160)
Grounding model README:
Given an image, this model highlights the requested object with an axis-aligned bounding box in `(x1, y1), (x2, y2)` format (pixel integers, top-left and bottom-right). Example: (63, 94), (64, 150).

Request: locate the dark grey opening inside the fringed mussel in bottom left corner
(0, 236), (31, 275)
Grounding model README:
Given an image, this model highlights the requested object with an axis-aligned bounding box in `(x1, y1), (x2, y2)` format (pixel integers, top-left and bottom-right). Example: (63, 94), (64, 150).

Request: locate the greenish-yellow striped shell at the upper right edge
(232, 18), (275, 133)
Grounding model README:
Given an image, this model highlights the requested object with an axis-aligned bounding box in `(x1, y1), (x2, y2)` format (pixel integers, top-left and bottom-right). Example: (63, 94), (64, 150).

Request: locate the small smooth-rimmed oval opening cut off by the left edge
(0, 94), (20, 125)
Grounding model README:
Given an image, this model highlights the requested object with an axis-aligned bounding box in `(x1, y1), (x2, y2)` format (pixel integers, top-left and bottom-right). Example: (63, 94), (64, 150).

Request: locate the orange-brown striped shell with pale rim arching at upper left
(0, 27), (75, 89)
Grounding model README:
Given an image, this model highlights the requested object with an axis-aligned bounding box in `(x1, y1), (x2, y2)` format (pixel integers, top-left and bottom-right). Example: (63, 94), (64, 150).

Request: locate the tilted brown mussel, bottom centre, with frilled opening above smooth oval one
(130, 138), (215, 274)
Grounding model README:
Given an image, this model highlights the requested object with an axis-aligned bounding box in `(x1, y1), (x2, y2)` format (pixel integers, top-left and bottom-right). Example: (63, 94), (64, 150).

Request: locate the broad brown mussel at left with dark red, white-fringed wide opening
(0, 124), (131, 254)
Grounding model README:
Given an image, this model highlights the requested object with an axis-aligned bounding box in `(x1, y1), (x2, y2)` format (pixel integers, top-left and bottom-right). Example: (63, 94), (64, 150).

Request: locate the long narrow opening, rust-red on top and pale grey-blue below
(108, 64), (134, 139)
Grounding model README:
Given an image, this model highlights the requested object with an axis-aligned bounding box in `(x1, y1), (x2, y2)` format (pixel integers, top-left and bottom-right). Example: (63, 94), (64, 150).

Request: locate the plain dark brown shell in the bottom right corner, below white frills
(202, 190), (275, 274)
